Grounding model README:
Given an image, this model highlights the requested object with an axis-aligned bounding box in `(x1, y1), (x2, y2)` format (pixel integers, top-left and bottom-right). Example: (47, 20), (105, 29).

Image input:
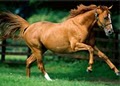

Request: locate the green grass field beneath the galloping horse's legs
(0, 60), (120, 86)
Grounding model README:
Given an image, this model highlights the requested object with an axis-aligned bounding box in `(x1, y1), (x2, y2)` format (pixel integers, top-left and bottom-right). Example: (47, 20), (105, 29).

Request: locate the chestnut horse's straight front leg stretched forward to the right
(94, 46), (120, 75)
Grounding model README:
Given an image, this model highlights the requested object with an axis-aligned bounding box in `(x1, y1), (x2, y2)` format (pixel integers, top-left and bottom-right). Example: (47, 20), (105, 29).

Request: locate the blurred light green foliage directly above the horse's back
(28, 8), (68, 23)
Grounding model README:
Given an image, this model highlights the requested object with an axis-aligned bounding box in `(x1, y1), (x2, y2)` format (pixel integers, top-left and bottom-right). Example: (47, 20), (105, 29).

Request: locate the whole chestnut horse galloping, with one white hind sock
(0, 4), (120, 80)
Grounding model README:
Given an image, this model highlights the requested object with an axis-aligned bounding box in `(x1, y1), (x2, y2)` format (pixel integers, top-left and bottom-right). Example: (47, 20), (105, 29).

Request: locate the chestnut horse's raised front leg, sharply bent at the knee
(75, 43), (93, 72)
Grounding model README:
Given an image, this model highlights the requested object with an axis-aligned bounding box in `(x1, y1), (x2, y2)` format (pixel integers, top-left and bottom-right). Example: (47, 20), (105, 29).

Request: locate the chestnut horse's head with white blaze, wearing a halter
(95, 6), (114, 36)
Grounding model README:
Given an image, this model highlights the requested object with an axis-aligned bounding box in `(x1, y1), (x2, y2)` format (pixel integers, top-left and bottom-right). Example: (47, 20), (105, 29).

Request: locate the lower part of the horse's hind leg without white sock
(26, 54), (36, 77)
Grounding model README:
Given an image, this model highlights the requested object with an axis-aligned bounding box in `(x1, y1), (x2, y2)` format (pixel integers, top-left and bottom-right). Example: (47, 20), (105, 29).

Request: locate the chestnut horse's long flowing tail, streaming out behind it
(0, 12), (30, 39)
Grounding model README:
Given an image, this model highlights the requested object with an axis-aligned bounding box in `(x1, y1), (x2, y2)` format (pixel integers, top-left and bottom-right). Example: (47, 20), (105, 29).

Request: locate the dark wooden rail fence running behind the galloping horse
(0, 30), (120, 65)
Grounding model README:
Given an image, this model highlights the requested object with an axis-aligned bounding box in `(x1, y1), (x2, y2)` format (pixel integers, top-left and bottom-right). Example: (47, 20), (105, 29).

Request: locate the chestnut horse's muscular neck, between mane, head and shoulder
(76, 10), (96, 29)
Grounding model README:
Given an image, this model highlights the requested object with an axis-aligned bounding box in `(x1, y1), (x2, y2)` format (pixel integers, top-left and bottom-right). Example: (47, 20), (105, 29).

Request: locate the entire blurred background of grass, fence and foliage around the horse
(0, 0), (120, 86)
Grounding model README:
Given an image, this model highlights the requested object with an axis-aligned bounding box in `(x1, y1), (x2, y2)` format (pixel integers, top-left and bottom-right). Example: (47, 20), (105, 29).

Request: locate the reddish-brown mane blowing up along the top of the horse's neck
(68, 4), (97, 18)
